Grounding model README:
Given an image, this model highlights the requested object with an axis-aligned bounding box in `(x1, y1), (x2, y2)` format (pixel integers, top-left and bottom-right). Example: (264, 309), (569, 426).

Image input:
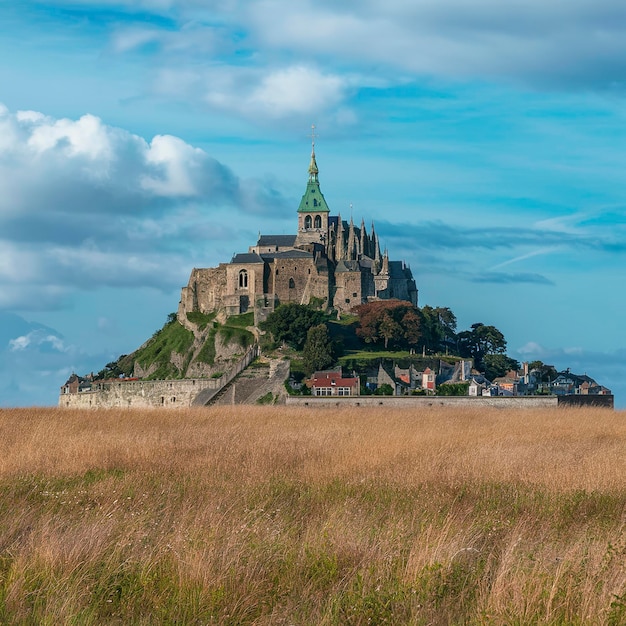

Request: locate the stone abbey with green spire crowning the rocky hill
(178, 143), (417, 323)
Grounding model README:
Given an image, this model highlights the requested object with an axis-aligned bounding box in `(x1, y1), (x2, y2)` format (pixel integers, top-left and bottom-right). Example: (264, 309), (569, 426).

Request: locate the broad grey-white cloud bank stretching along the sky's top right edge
(247, 0), (626, 84)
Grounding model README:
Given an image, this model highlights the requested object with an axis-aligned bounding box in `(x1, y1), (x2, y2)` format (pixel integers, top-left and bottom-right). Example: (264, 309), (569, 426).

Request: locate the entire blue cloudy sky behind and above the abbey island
(0, 0), (626, 407)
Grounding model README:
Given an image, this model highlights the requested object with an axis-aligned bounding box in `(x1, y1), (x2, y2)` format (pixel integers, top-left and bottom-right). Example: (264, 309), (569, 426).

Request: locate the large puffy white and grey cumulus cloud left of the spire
(0, 107), (286, 309)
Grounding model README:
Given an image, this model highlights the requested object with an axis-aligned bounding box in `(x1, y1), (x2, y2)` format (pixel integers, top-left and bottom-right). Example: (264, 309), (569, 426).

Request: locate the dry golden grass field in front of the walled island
(0, 406), (626, 626)
